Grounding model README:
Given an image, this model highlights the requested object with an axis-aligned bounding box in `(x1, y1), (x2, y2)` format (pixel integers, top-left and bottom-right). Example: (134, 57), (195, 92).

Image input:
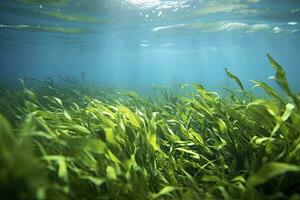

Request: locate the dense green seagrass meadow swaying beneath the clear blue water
(0, 56), (300, 200)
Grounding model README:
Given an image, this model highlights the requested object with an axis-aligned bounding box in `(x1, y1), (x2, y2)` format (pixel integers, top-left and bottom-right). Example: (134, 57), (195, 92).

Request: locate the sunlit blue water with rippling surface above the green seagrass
(0, 0), (300, 91)
